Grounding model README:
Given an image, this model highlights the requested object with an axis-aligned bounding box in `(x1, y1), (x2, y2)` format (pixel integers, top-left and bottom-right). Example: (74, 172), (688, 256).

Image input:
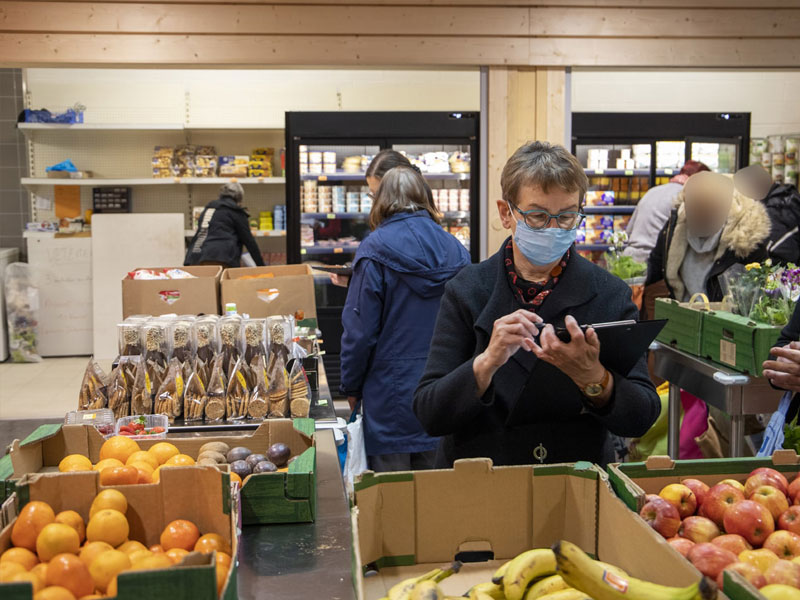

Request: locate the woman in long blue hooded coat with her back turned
(341, 167), (469, 471)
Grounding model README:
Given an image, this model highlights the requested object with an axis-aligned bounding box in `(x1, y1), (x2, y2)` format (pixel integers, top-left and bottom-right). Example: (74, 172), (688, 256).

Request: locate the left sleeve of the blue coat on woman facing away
(341, 258), (385, 398)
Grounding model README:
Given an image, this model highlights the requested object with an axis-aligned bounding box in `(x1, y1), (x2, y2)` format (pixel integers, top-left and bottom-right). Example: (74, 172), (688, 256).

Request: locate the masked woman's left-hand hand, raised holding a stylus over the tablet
(472, 308), (542, 396)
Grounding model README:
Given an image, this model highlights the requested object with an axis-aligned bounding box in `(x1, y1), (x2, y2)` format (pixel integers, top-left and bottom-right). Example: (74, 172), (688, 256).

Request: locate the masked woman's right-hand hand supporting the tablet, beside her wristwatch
(533, 316), (611, 404)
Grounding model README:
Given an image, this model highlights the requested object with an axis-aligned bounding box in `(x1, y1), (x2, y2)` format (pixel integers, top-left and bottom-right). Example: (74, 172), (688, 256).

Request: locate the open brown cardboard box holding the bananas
(352, 459), (701, 600)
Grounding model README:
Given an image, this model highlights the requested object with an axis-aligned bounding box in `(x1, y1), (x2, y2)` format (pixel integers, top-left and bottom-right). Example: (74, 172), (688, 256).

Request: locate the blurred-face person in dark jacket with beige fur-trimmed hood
(645, 172), (770, 304)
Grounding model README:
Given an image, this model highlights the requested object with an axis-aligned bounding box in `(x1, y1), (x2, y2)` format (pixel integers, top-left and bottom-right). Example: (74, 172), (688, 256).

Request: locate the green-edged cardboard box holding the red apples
(608, 450), (800, 600)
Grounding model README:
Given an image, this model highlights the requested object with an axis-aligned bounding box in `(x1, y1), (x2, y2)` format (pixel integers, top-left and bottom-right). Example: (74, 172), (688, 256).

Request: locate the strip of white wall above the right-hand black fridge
(571, 69), (800, 137)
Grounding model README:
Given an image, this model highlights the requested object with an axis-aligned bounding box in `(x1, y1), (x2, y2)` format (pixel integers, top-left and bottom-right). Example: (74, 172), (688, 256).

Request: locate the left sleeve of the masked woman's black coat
(414, 282), (494, 436)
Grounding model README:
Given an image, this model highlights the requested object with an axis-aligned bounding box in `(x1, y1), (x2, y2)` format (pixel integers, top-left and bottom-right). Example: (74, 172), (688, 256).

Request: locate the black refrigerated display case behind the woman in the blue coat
(286, 112), (480, 390)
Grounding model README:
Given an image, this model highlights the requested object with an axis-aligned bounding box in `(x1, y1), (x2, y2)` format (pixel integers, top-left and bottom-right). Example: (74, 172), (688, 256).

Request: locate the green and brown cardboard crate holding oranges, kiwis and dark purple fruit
(5, 419), (317, 525)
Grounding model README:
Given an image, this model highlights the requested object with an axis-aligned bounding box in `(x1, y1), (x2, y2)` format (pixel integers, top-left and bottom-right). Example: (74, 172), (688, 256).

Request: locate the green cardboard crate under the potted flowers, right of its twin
(701, 311), (782, 377)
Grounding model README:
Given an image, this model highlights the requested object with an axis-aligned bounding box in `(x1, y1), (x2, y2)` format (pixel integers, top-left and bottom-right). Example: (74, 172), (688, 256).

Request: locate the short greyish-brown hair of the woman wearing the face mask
(500, 142), (589, 205)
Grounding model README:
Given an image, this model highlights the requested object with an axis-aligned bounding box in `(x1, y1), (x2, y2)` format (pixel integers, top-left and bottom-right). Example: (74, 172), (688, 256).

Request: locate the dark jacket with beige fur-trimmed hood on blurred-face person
(647, 191), (770, 302)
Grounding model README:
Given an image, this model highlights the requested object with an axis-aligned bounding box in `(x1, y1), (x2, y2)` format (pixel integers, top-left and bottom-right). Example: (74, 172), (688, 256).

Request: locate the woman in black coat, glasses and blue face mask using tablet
(414, 142), (660, 467)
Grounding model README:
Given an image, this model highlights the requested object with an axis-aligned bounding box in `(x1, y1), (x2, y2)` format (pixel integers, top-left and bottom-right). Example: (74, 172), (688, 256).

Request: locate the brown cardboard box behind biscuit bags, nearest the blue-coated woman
(221, 265), (317, 318)
